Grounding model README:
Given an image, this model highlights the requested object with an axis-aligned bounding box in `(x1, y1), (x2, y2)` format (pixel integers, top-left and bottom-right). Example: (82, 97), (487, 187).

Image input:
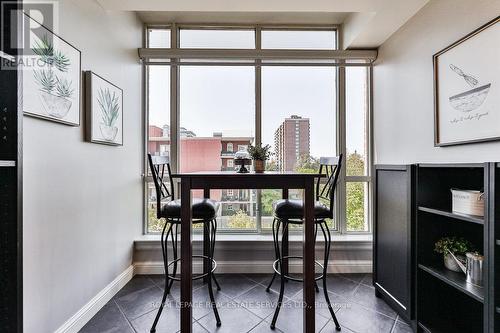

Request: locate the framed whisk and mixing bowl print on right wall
(433, 16), (500, 146)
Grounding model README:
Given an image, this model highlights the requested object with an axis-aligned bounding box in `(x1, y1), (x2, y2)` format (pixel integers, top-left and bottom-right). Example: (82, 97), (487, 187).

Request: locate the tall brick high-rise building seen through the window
(274, 115), (310, 171)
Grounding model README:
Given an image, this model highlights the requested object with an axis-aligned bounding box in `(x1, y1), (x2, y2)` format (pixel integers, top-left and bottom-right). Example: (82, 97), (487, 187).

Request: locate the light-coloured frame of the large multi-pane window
(143, 23), (373, 234)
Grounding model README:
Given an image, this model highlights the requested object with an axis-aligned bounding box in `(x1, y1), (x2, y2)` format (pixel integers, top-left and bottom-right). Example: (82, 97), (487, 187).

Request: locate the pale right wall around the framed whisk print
(374, 0), (500, 164)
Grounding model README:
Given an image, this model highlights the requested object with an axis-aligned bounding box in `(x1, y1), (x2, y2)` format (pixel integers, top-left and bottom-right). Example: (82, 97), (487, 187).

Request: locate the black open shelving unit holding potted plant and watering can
(414, 163), (493, 333)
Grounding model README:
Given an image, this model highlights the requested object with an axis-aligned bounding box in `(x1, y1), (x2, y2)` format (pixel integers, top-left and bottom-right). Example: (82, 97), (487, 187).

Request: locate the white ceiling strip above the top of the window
(96, 0), (429, 48)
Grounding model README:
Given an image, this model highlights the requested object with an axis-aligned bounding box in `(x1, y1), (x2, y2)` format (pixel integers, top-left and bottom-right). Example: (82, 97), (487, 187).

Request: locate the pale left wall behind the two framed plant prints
(23, 0), (143, 333)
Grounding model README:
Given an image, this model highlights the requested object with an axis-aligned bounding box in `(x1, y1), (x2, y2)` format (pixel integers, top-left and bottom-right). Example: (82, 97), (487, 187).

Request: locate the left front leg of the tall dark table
(181, 178), (193, 333)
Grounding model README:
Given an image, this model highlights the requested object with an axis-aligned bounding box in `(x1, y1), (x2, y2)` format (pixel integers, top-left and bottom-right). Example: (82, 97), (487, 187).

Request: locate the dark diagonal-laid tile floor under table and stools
(80, 274), (412, 333)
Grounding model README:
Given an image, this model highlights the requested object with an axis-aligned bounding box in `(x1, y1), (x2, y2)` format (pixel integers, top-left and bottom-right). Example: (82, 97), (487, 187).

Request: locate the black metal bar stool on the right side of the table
(266, 155), (342, 331)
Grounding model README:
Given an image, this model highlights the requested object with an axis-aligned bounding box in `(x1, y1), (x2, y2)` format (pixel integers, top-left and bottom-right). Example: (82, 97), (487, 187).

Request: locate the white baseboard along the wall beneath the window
(134, 260), (372, 275)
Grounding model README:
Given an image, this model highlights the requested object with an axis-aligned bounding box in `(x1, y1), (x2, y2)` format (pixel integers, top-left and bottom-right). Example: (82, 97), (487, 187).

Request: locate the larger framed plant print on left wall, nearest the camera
(22, 14), (81, 126)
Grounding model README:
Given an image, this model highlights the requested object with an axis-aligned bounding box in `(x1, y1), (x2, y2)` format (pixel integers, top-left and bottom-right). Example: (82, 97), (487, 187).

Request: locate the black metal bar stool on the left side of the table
(148, 154), (221, 332)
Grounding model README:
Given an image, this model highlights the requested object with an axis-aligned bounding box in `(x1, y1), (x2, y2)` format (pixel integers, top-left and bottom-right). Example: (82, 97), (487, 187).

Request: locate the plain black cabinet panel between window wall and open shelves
(374, 165), (414, 320)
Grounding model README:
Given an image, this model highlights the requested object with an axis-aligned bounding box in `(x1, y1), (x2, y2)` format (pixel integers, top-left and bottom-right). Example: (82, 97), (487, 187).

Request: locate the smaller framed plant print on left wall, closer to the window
(85, 71), (123, 146)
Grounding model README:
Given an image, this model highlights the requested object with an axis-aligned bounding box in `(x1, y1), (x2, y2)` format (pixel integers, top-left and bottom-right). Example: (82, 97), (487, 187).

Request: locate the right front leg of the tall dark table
(303, 179), (315, 333)
